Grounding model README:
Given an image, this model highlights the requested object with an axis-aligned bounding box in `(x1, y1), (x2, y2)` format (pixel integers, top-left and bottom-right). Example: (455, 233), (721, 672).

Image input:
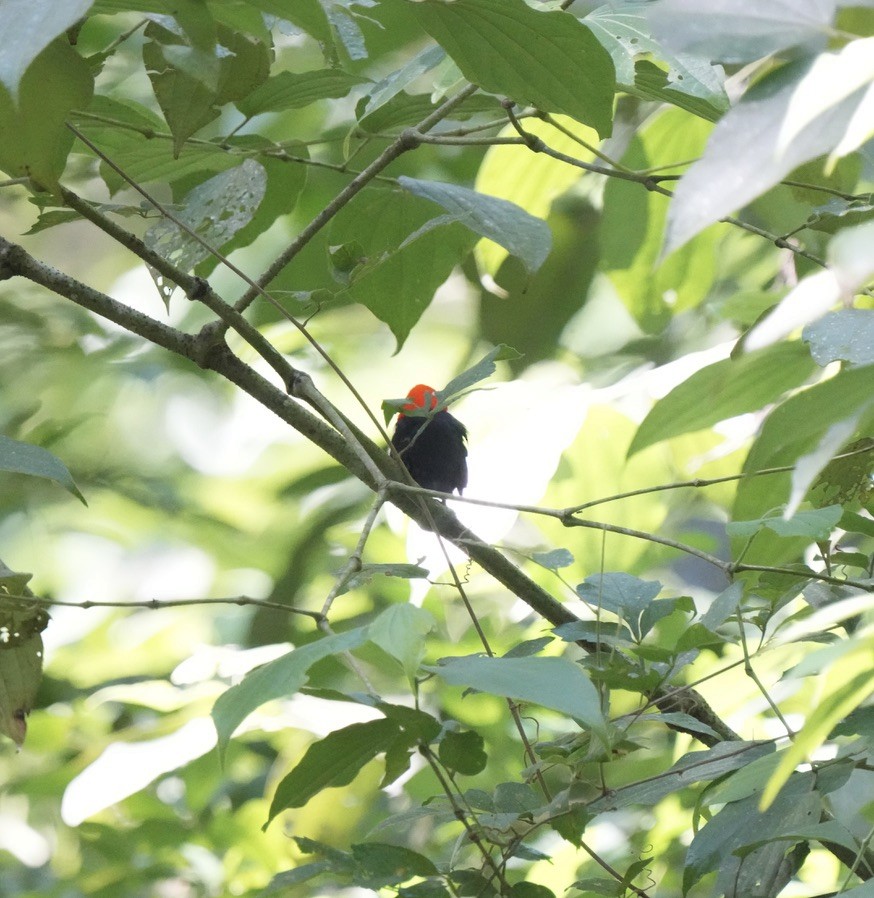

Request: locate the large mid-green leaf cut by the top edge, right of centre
(413, 0), (615, 137)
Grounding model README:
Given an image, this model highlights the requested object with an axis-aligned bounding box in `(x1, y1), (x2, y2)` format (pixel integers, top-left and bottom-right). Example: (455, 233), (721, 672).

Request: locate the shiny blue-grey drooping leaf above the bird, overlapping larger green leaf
(398, 175), (552, 273)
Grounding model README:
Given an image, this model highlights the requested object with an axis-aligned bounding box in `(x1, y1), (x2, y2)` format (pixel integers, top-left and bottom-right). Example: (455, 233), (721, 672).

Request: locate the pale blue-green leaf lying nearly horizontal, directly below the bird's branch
(433, 655), (605, 733)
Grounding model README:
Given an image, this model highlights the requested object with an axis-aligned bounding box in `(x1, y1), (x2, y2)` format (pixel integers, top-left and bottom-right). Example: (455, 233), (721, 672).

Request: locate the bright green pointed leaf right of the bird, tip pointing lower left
(628, 342), (815, 457)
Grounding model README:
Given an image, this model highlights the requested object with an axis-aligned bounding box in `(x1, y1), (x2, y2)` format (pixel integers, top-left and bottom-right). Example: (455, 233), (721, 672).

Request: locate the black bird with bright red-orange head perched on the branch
(391, 384), (467, 495)
